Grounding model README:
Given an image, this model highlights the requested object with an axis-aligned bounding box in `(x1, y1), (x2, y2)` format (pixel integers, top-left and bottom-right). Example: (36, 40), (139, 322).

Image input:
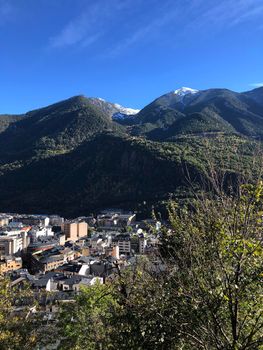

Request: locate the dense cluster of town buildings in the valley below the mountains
(0, 210), (161, 300)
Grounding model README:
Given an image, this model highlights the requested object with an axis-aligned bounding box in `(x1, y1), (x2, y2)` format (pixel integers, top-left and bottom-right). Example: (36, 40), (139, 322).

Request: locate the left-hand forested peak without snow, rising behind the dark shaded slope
(0, 96), (125, 163)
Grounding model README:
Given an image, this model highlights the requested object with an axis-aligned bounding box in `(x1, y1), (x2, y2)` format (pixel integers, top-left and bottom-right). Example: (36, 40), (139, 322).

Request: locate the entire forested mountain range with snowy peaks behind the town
(0, 88), (263, 216)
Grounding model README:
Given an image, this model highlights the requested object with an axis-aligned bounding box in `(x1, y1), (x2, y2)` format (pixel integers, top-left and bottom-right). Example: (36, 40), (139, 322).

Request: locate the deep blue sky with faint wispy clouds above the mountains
(0, 0), (263, 113)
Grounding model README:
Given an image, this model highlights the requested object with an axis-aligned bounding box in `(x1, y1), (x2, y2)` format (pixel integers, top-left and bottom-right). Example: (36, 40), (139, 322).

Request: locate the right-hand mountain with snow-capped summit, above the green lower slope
(129, 88), (263, 141)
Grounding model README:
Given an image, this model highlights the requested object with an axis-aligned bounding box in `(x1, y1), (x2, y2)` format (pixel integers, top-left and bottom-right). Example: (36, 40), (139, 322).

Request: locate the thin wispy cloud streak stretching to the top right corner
(109, 0), (263, 57)
